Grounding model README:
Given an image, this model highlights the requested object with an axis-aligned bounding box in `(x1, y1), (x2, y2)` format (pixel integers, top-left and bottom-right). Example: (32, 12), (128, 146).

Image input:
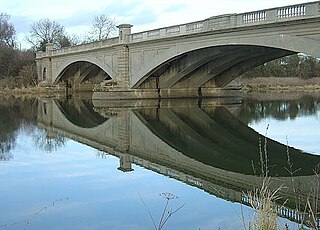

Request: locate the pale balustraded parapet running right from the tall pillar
(131, 1), (320, 42)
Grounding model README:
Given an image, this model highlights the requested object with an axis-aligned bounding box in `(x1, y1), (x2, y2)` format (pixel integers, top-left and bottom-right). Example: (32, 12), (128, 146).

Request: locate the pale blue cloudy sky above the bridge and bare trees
(0, 0), (312, 46)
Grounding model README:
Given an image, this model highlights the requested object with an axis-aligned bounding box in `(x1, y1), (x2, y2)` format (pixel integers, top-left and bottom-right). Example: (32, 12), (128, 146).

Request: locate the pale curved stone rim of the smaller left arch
(52, 55), (117, 84)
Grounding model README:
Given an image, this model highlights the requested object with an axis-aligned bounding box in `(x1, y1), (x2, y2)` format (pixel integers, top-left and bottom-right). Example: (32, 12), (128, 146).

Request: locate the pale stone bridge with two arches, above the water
(36, 1), (320, 99)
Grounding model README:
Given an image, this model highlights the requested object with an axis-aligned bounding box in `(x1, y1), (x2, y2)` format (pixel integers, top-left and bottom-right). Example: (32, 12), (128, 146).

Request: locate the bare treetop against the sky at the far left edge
(0, 12), (16, 47)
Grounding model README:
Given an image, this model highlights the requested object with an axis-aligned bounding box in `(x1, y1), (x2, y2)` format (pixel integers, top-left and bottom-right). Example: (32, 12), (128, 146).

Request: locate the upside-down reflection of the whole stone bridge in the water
(38, 99), (320, 226)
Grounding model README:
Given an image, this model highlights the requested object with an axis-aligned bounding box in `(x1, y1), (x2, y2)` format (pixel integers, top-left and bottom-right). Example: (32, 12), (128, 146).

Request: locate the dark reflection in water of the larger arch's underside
(135, 107), (320, 177)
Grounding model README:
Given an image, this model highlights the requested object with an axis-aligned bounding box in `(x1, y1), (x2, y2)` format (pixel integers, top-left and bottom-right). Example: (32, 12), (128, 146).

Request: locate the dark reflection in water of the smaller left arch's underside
(55, 99), (108, 128)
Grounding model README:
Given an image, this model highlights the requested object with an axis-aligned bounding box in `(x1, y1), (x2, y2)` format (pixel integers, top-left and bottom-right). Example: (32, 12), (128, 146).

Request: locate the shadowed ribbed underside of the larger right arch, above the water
(133, 44), (296, 89)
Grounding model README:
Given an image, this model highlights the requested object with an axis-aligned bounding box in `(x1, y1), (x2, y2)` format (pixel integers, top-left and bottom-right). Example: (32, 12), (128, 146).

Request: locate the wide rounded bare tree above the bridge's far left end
(27, 18), (66, 51)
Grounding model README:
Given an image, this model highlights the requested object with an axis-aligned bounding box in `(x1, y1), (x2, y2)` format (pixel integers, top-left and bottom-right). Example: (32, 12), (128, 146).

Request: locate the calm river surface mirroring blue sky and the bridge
(0, 94), (320, 230)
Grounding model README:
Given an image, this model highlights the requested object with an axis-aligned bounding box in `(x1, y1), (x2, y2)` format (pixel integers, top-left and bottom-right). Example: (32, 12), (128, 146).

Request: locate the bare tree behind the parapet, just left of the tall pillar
(90, 14), (116, 41)
